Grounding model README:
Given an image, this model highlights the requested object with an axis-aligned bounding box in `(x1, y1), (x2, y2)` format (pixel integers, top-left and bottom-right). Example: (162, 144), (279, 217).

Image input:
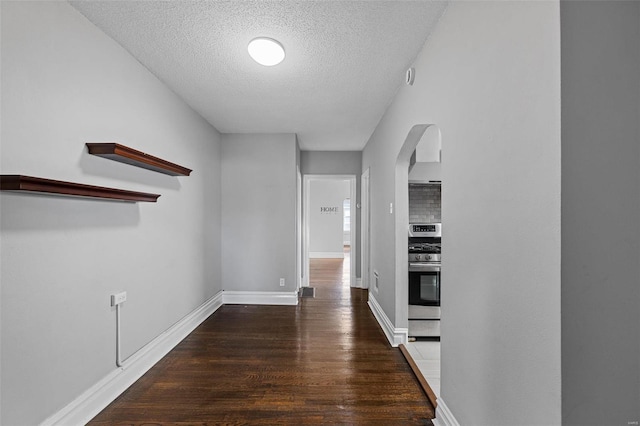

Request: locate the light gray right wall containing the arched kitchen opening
(363, 2), (561, 425)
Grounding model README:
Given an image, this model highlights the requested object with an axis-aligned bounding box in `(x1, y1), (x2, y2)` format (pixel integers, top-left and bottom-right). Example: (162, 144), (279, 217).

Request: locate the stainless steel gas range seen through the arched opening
(408, 223), (442, 338)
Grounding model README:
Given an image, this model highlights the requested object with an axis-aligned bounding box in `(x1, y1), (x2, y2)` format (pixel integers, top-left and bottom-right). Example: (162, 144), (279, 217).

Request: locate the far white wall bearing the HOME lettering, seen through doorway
(309, 179), (351, 258)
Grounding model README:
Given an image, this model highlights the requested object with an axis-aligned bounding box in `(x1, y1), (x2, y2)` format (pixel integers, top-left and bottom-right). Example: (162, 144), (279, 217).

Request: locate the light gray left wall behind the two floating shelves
(0, 2), (221, 425)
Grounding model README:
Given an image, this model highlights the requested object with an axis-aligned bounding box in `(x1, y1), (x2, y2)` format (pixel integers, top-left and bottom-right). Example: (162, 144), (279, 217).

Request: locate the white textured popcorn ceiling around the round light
(71, 0), (446, 151)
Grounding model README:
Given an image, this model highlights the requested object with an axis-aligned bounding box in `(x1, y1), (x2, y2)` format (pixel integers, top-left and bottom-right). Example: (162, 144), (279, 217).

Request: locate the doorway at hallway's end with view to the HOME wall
(302, 175), (357, 287)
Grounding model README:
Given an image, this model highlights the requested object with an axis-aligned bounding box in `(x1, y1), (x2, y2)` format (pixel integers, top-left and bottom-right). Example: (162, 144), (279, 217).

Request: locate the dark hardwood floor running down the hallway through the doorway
(89, 248), (434, 425)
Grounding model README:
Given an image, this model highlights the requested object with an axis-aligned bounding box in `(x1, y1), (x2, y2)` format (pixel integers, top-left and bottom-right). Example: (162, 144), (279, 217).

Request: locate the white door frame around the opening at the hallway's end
(302, 175), (359, 287)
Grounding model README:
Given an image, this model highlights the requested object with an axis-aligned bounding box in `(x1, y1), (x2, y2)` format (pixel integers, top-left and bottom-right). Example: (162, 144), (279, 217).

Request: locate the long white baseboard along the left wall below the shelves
(41, 292), (223, 426)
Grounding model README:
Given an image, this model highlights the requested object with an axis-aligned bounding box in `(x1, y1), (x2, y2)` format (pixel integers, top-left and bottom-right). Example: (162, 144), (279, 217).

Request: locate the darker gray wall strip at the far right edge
(561, 1), (640, 425)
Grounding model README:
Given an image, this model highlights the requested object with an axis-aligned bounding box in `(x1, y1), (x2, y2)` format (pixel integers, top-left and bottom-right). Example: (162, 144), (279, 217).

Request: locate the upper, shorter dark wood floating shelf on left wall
(87, 142), (191, 176)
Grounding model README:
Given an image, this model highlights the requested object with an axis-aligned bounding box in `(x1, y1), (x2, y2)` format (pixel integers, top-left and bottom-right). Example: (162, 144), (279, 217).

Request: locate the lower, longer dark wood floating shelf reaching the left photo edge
(0, 175), (160, 203)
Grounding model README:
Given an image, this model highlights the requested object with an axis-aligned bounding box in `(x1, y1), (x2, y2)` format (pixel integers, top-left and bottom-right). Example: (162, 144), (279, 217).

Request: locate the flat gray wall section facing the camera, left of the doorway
(222, 134), (297, 292)
